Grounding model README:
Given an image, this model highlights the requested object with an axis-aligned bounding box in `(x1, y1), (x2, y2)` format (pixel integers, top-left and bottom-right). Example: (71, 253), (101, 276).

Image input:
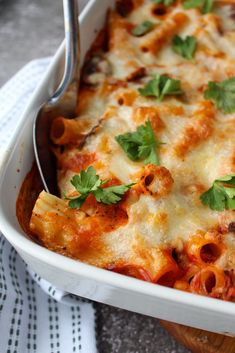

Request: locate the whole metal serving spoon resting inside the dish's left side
(33, 0), (80, 195)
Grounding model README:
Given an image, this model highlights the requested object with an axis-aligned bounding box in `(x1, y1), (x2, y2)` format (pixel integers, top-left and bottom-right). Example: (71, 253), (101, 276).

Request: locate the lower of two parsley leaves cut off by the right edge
(200, 174), (235, 211)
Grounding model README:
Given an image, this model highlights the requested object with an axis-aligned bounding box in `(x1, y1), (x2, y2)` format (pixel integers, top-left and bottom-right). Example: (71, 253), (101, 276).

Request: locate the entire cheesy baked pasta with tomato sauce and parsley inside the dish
(21, 0), (235, 301)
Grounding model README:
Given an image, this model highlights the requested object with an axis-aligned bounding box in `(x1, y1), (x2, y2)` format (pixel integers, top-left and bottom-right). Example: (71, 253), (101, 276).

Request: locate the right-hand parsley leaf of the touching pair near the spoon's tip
(94, 184), (134, 205)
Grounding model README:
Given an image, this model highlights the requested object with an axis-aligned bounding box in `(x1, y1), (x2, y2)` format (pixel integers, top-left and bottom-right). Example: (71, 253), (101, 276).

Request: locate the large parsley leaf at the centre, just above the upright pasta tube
(115, 120), (162, 165)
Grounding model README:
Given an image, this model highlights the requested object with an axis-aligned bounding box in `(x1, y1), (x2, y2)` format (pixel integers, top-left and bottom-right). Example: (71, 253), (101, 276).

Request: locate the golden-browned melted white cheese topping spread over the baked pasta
(30, 0), (235, 294)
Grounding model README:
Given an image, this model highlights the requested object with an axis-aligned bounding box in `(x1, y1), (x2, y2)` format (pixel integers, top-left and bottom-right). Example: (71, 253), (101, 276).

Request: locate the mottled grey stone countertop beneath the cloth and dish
(0, 0), (188, 353)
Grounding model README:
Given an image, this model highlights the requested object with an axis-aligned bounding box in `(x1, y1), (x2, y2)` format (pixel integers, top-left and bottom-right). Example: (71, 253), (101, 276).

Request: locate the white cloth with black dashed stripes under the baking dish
(0, 58), (97, 353)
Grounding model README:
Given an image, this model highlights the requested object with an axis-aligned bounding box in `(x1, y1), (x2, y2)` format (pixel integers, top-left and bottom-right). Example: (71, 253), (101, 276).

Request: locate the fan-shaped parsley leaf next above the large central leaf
(139, 74), (183, 101)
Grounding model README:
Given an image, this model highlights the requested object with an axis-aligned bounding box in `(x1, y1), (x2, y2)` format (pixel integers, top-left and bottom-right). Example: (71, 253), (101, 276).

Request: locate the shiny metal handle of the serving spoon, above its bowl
(48, 0), (80, 107)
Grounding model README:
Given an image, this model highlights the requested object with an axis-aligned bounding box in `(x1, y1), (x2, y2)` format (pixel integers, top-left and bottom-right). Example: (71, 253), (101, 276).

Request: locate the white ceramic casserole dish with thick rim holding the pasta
(0, 0), (235, 335)
